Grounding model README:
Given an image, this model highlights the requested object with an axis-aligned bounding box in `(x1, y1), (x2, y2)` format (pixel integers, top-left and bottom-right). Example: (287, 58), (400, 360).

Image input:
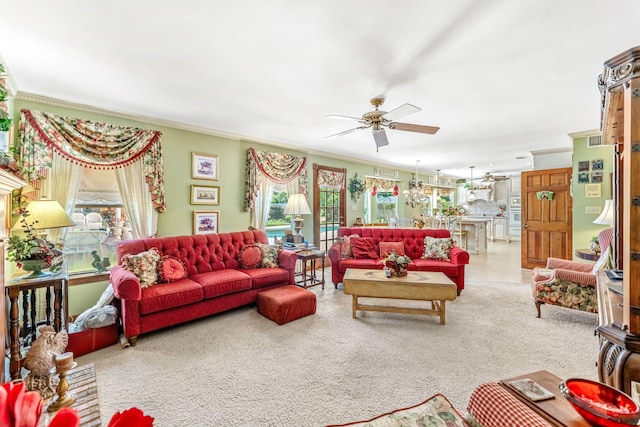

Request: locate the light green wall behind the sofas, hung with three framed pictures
(12, 98), (418, 314)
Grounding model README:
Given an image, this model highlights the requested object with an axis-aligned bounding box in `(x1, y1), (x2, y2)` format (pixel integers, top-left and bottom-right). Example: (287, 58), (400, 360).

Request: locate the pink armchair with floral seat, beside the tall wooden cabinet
(531, 228), (613, 317)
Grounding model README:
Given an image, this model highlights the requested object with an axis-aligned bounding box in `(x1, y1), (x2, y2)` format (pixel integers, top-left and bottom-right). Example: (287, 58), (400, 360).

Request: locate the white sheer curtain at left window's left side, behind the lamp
(44, 151), (82, 242)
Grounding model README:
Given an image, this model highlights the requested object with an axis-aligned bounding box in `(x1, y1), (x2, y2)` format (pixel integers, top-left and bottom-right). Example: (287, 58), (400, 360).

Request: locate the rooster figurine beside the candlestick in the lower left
(24, 325), (69, 400)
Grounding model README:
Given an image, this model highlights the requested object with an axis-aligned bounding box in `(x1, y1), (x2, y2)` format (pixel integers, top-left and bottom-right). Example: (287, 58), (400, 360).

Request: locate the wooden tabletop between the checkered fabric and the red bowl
(499, 371), (591, 427)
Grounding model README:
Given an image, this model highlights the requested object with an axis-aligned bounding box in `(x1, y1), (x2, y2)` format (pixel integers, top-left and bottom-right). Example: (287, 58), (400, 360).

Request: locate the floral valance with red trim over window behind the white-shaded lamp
(245, 148), (308, 211)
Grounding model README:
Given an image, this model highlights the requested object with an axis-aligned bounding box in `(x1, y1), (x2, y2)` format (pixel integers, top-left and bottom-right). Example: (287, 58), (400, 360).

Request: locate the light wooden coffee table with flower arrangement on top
(342, 268), (458, 325)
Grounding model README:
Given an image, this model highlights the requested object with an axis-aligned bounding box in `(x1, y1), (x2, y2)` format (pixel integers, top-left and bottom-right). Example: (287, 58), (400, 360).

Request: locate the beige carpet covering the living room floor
(77, 276), (598, 427)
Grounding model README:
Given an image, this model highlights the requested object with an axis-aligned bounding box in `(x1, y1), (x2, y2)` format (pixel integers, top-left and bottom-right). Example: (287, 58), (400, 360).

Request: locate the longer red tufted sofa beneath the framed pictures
(110, 230), (297, 345)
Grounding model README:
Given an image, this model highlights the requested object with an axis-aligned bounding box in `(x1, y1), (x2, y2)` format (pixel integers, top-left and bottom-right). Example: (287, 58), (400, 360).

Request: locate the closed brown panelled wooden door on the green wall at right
(521, 168), (573, 268)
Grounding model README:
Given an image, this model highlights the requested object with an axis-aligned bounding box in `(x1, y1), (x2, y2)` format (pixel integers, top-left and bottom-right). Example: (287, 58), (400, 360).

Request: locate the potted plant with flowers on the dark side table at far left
(7, 208), (63, 277)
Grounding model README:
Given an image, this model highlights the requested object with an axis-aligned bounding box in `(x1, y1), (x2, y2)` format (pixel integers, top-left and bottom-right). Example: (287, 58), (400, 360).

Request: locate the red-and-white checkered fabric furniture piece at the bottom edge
(467, 383), (551, 427)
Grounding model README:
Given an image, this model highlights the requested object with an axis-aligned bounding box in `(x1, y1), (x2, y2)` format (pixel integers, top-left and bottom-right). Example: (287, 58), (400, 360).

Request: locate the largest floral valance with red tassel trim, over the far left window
(16, 109), (165, 212)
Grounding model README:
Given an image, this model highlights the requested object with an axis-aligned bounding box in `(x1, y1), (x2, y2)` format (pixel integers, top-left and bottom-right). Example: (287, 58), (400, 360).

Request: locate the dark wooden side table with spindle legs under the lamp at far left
(5, 264), (69, 380)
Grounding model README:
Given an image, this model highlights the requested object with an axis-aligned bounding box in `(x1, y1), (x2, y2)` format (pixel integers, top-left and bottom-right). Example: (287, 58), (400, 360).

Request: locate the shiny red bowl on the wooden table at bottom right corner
(560, 378), (640, 427)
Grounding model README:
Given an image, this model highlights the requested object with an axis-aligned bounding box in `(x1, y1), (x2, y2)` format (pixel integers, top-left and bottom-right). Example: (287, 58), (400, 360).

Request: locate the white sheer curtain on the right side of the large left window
(116, 159), (158, 238)
